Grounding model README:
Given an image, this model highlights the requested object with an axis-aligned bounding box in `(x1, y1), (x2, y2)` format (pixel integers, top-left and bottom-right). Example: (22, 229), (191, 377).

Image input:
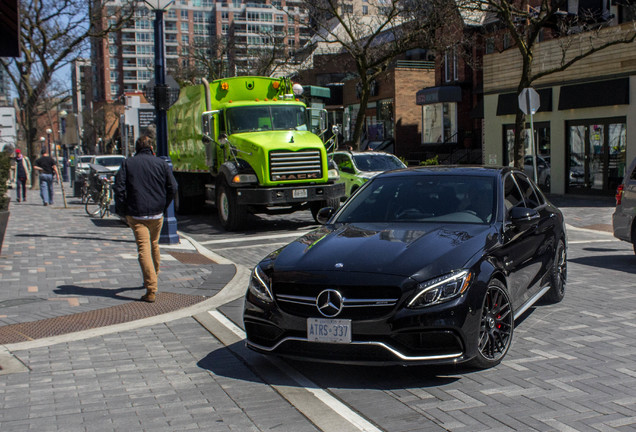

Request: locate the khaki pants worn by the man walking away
(126, 216), (163, 293)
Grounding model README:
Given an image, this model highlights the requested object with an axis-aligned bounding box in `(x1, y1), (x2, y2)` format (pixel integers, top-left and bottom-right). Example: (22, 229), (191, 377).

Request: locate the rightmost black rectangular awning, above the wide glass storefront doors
(559, 78), (629, 110)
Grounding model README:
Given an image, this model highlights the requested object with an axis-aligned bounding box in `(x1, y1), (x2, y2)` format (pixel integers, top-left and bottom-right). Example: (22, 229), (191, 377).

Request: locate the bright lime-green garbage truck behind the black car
(168, 76), (345, 231)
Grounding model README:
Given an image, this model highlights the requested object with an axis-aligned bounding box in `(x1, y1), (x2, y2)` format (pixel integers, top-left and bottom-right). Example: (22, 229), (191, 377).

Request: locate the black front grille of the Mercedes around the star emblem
(273, 283), (401, 319)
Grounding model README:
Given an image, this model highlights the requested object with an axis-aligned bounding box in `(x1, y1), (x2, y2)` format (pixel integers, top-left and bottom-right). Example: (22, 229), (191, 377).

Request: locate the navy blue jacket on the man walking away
(113, 149), (177, 217)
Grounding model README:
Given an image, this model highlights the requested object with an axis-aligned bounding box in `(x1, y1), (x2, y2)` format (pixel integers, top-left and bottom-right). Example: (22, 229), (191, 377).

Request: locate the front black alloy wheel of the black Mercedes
(472, 279), (514, 369)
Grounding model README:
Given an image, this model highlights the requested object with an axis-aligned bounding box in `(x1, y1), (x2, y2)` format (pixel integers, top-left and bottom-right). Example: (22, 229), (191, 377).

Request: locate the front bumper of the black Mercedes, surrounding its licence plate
(244, 272), (483, 365)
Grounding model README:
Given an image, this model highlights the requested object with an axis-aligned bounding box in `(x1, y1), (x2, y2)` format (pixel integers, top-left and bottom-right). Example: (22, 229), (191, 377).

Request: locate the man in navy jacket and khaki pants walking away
(113, 136), (177, 303)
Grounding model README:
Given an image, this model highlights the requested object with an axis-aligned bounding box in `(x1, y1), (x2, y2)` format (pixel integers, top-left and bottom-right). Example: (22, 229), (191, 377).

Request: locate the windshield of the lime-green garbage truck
(226, 105), (307, 134)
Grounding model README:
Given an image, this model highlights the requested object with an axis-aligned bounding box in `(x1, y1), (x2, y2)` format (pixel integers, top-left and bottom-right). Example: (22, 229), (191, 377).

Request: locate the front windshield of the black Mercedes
(335, 174), (495, 224)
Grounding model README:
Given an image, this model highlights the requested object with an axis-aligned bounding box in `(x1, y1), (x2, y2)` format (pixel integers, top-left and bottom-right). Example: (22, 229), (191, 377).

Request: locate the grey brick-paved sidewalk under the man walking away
(0, 189), (235, 333)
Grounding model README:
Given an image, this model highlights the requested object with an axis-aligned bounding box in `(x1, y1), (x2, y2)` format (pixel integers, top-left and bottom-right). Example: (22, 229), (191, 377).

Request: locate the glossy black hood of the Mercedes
(268, 223), (497, 280)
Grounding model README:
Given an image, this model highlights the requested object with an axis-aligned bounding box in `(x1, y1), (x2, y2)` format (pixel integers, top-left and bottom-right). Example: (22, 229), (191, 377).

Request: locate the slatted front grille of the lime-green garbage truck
(269, 150), (322, 181)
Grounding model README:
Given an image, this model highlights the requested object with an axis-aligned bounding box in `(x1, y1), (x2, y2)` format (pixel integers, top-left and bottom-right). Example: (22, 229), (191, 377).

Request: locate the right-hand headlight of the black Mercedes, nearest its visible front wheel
(407, 270), (473, 308)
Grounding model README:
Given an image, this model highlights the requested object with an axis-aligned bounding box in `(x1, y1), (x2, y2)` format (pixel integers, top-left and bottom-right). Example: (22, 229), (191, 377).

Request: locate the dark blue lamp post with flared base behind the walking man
(144, 0), (179, 244)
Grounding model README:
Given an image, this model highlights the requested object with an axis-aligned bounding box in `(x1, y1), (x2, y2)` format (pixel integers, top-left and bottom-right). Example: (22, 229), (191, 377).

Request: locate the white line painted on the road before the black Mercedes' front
(208, 310), (381, 432)
